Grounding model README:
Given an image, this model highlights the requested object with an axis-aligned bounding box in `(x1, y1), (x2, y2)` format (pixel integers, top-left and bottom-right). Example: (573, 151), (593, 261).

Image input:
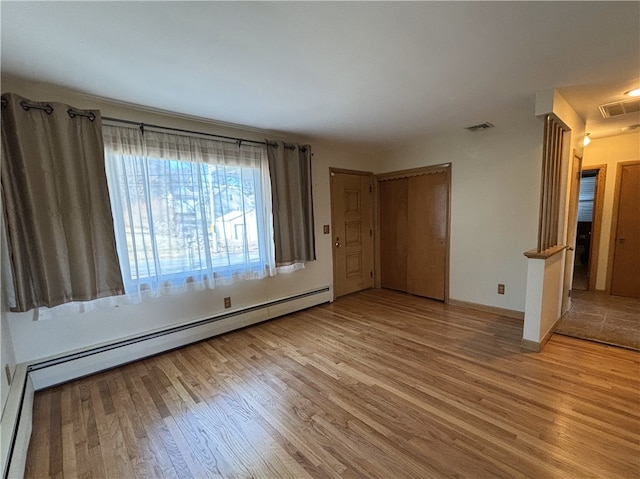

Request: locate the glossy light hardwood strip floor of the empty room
(26, 290), (640, 479)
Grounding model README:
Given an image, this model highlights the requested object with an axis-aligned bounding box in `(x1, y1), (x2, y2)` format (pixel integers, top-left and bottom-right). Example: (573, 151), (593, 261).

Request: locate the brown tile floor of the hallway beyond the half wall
(555, 290), (640, 351)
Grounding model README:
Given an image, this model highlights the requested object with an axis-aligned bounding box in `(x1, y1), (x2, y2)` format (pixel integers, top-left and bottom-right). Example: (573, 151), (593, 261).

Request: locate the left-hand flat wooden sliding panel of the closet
(378, 178), (409, 291)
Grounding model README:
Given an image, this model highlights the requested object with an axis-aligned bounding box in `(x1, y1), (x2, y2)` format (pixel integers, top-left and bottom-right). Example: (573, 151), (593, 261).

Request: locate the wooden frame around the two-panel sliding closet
(373, 163), (451, 304)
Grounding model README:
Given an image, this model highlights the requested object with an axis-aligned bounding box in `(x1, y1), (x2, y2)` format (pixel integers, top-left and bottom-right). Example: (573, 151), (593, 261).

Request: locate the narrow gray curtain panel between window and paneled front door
(266, 141), (316, 266)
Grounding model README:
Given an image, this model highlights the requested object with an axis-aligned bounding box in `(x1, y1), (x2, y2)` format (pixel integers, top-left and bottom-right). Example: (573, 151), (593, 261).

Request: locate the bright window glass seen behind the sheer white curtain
(118, 155), (262, 280)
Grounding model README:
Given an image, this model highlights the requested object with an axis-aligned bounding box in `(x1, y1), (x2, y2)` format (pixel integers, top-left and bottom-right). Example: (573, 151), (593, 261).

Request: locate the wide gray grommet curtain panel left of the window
(1, 93), (124, 311)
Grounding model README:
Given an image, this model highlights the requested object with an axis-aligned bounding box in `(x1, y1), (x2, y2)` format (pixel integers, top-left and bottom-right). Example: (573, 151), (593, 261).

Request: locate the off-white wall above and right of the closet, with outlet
(378, 106), (543, 311)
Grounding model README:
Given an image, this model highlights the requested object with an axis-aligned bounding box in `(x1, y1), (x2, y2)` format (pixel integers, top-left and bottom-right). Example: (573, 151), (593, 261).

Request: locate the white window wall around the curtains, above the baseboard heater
(2, 77), (380, 363)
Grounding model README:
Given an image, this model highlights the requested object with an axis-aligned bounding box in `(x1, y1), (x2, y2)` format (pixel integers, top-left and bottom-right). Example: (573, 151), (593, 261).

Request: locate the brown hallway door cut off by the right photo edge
(610, 164), (640, 298)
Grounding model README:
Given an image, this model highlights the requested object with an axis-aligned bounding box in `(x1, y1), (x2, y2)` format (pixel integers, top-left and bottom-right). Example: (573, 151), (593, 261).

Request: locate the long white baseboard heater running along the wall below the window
(0, 286), (333, 479)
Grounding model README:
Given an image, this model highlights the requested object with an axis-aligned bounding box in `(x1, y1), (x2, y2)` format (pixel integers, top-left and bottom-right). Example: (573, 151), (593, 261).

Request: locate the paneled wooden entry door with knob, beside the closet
(331, 170), (373, 297)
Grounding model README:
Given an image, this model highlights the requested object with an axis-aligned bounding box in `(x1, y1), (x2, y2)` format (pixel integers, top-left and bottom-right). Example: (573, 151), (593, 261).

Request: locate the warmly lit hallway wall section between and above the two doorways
(582, 132), (640, 290)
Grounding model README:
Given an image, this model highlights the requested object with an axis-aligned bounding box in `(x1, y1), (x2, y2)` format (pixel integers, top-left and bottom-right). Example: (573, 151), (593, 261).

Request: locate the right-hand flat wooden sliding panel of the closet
(407, 171), (449, 301)
